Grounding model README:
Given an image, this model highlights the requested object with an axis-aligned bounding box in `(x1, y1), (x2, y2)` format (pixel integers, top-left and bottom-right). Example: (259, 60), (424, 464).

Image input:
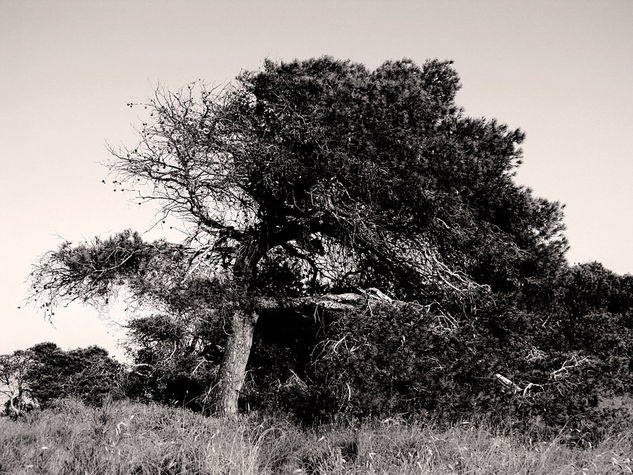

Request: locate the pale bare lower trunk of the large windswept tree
(215, 309), (258, 416)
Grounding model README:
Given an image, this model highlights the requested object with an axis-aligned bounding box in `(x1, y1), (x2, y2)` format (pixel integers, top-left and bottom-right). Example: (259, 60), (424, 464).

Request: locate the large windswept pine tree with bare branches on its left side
(28, 57), (566, 414)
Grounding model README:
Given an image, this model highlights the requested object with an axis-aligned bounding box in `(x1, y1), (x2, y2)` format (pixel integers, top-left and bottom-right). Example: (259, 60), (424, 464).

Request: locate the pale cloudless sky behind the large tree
(0, 0), (633, 358)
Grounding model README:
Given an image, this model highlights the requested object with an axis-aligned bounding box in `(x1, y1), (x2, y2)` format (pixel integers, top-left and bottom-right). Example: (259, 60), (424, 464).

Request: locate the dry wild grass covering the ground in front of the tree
(0, 401), (633, 474)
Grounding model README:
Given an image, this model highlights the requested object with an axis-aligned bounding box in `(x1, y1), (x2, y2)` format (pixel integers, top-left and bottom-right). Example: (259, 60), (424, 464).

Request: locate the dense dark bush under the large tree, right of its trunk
(287, 305), (633, 443)
